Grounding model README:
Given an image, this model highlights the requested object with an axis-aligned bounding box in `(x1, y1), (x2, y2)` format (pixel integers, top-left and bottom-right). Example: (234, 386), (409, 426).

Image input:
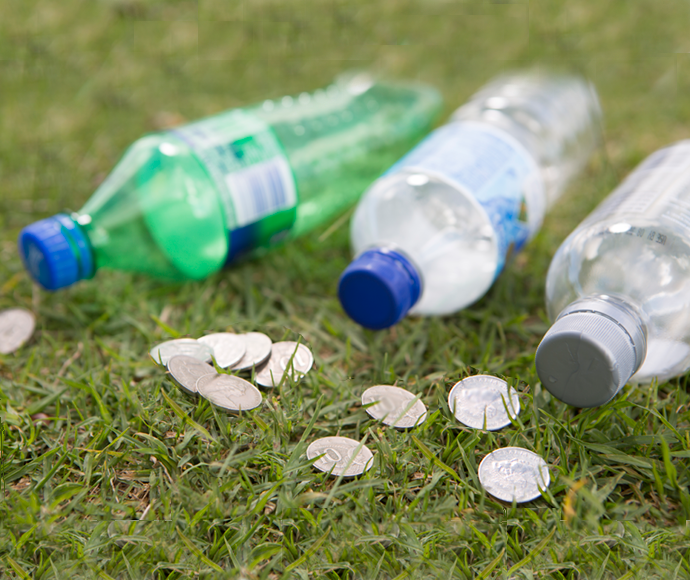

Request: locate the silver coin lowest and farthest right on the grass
(478, 447), (551, 503)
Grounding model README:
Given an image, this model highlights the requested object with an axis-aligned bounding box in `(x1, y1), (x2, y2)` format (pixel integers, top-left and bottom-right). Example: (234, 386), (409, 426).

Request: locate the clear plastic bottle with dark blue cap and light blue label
(338, 70), (600, 329)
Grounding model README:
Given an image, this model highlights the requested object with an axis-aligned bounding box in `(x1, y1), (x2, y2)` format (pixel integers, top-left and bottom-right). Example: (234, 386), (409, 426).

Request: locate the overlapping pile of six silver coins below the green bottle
(149, 332), (314, 413)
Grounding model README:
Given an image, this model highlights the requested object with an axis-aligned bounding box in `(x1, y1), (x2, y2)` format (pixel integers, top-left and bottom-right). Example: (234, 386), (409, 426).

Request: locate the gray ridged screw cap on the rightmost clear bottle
(535, 298), (647, 407)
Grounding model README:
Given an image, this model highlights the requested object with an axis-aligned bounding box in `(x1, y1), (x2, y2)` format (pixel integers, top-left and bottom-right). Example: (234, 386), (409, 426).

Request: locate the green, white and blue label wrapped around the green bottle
(172, 109), (297, 262)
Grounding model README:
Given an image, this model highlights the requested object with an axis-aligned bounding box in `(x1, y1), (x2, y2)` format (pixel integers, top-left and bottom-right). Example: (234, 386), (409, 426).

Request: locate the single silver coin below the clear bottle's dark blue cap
(362, 385), (426, 429)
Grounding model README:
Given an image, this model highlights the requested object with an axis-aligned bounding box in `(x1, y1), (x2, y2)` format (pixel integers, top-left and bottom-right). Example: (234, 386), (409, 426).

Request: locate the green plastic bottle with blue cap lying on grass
(19, 74), (441, 290)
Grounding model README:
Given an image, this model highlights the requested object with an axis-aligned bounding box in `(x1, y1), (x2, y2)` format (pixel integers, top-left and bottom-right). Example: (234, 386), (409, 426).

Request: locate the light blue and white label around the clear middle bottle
(388, 121), (546, 275)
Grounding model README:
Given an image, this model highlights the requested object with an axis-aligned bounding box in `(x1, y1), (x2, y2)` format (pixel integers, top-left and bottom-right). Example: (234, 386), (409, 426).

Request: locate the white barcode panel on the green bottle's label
(225, 157), (297, 227)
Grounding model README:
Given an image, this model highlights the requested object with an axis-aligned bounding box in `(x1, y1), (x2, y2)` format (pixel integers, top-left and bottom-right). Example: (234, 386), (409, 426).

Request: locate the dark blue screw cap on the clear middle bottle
(338, 248), (422, 330)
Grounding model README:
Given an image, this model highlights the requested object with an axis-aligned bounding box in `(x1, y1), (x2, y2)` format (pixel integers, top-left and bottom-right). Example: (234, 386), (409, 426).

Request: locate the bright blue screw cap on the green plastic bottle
(18, 214), (94, 290)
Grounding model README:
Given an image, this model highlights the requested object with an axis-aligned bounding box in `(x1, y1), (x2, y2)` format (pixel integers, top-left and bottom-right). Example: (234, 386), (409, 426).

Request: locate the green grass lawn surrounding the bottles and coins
(0, 0), (690, 580)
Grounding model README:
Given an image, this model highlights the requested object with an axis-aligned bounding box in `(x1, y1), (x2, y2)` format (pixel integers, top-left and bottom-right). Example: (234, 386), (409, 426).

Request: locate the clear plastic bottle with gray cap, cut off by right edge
(536, 140), (690, 407)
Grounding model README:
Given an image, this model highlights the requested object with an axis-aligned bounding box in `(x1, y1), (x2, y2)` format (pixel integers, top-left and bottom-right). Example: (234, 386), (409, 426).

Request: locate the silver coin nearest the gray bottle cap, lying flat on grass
(448, 375), (520, 431)
